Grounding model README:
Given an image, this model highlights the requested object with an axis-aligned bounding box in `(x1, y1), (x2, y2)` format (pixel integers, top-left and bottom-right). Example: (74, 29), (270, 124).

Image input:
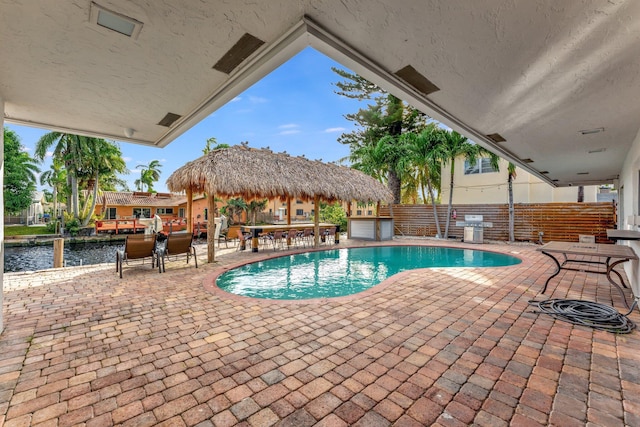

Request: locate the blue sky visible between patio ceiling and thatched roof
(6, 48), (366, 192)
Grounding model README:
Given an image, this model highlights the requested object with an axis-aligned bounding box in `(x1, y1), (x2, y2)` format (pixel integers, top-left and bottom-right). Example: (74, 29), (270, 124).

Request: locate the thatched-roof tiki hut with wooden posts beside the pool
(167, 145), (393, 262)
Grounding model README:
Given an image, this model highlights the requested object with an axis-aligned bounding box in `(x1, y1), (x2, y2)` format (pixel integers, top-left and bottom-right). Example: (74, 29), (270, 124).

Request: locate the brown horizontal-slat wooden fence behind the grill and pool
(380, 202), (616, 243)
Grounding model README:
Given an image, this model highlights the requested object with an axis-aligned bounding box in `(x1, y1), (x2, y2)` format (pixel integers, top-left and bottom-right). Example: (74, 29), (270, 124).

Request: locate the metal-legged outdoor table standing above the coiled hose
(538, 242), (638, 308)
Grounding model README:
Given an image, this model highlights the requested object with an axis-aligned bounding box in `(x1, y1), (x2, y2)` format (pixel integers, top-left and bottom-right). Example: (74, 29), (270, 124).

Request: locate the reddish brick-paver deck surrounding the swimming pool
(0, 239), (640, 427)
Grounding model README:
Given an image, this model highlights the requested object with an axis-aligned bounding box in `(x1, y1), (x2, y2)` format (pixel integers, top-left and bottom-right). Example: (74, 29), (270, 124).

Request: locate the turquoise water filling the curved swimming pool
(216, 246), (521, 300)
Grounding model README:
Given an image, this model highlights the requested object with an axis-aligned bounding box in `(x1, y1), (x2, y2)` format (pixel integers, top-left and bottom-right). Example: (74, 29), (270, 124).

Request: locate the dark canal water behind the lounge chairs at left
(4, 241), (124, 272)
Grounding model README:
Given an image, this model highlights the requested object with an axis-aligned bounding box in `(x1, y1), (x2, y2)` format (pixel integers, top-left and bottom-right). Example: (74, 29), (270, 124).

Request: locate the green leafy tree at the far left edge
(3, 128), (40, 214)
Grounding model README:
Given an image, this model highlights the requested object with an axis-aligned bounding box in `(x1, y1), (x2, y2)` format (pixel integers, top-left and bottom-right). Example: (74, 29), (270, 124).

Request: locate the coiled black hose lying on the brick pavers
(529, 299), (637, 334)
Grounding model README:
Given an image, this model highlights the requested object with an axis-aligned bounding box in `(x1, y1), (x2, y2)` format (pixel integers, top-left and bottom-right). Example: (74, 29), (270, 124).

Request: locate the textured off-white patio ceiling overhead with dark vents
(0, 0), (640, 185)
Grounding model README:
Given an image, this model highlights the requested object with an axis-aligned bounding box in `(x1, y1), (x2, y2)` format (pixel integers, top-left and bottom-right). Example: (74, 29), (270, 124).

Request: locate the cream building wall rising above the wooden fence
(442, 158), (598, 204)
